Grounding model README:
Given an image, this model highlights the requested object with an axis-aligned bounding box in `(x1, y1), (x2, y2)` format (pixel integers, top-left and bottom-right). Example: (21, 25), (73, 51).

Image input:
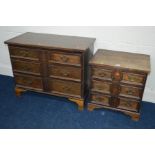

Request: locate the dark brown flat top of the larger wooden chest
(5, 32), (95, 51)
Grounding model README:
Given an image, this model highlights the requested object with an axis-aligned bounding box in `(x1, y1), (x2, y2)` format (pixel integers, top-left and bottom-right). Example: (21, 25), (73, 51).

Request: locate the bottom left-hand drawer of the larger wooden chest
(15, 74), (43, 90)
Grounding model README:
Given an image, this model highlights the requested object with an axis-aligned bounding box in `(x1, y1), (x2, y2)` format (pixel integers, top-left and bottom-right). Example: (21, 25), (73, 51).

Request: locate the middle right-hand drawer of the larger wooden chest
(49, 65), (81, 81)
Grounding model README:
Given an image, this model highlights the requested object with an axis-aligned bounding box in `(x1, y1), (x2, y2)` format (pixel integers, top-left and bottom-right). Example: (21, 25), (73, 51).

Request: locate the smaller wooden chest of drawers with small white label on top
(88, 49), (150, 120)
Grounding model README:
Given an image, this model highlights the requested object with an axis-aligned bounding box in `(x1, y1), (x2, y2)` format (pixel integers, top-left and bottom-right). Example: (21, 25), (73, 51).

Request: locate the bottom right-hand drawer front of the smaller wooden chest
(118, 98), (139, 112)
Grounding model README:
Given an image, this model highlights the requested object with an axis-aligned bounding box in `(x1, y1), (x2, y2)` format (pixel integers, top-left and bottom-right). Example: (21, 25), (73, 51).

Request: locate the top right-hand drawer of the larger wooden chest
(49, 52), (81, 66)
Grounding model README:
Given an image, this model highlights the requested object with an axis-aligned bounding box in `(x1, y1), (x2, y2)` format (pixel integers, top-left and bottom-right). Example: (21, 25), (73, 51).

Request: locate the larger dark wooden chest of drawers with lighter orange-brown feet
(5, 33), (95, 109)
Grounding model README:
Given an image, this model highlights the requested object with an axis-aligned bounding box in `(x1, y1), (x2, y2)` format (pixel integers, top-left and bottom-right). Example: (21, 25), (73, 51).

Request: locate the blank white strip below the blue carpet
(0, 130), (155, 155)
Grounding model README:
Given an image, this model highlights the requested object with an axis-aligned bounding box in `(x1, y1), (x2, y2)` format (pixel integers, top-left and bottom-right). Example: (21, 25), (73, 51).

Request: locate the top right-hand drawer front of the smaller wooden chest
(123, 72), (145, 85)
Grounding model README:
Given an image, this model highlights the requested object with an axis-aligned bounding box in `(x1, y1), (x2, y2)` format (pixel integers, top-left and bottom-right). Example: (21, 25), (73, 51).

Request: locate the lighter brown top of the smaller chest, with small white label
(90, 49), (150, 73)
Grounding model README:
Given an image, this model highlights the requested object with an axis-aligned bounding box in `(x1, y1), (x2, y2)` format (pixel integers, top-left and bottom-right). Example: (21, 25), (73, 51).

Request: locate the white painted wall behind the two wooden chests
(0, 26), (155, 103)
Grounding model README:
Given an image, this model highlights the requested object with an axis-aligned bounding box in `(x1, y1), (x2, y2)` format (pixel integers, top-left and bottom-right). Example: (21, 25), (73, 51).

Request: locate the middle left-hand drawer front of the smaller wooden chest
(92, 80), (111, 93)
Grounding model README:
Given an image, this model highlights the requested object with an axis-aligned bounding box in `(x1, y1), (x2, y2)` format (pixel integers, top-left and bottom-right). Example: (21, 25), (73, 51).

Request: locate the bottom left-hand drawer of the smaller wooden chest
(90, 94), (110, 106)
